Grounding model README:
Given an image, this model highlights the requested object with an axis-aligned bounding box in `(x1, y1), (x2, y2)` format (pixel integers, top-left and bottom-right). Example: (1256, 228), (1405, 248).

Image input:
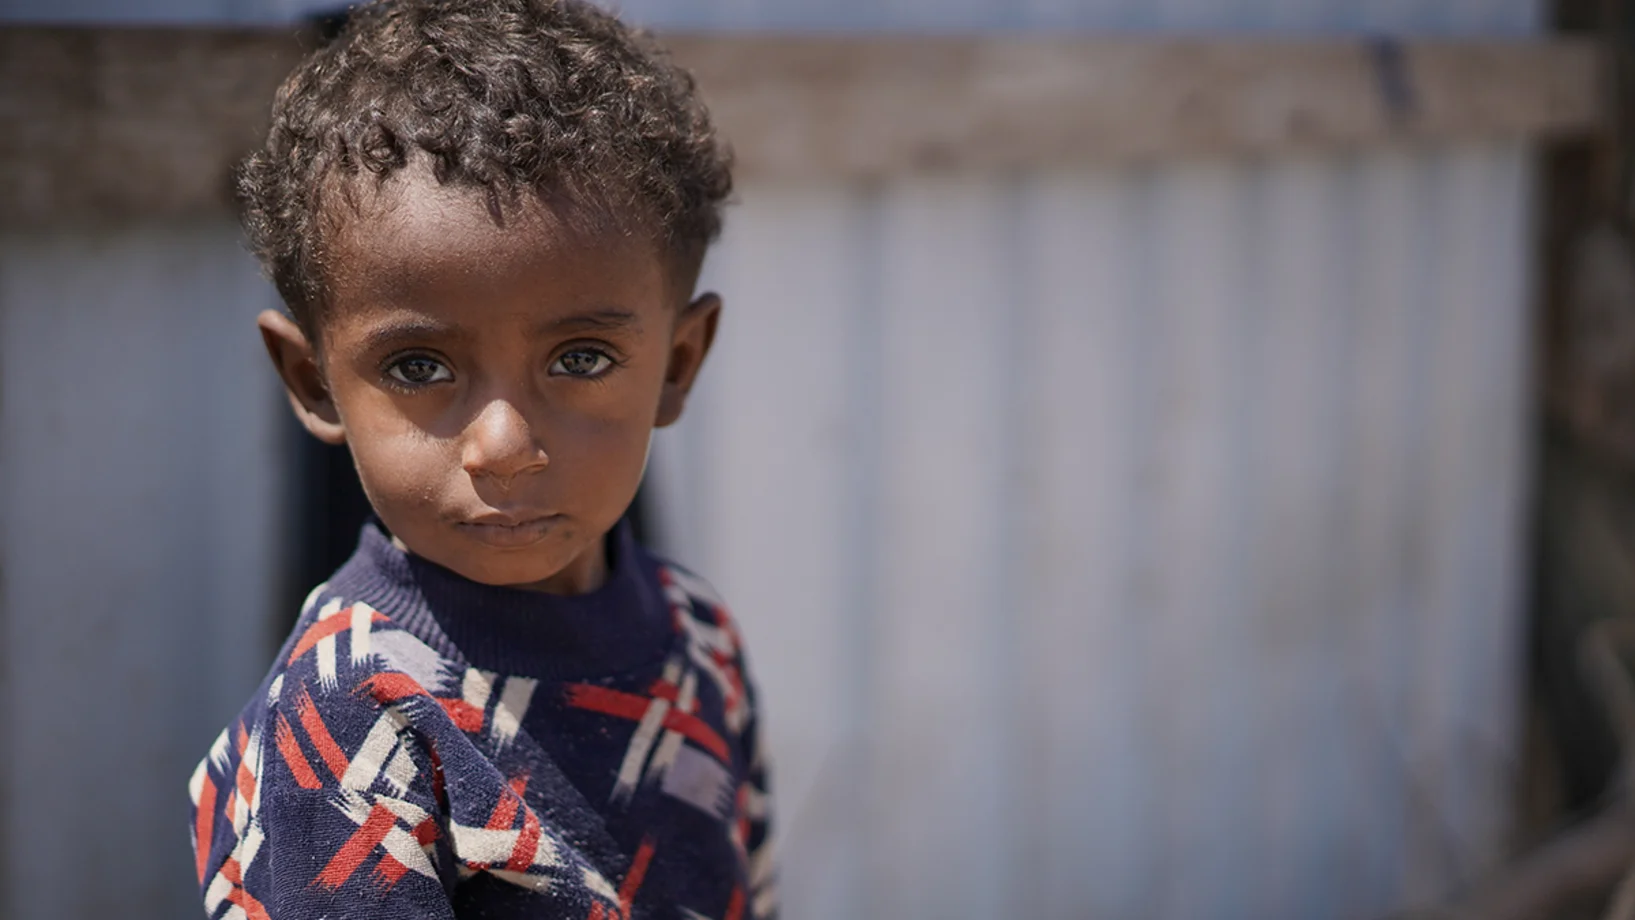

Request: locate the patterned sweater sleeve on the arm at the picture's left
(193, 675), (458, 920)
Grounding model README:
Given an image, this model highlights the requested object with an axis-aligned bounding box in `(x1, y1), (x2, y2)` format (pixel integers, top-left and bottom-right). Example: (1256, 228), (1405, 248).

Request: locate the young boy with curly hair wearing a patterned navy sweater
(191, 0), (775, 920)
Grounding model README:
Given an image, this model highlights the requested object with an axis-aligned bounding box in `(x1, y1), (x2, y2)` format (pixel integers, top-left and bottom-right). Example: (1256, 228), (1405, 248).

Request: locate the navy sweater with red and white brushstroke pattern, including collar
(190, 525), (777, 920)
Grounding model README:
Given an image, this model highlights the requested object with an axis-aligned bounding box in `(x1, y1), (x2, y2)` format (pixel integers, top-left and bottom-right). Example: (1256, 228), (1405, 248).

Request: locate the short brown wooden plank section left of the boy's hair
(0, 28), (299, 229)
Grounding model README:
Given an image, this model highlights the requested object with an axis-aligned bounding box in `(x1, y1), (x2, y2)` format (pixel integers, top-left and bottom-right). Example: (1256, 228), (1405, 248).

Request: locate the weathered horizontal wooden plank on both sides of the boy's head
(0, 26), (1601, 227)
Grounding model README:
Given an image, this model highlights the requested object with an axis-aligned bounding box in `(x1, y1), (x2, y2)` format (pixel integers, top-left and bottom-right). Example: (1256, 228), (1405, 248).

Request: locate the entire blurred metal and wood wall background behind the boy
(0, 0), (1635, 920)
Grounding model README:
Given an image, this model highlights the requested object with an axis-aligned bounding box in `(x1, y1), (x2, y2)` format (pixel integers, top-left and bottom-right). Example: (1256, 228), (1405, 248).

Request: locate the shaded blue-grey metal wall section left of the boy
(0, 221), (288, 920)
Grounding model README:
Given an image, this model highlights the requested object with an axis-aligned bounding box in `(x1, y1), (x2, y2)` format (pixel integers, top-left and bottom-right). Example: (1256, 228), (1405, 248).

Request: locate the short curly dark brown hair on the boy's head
(235, 0), (732, 337)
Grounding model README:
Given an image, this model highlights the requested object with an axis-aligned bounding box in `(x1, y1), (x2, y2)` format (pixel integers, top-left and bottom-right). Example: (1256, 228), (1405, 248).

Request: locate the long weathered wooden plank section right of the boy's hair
(670, 36), (1599, 175)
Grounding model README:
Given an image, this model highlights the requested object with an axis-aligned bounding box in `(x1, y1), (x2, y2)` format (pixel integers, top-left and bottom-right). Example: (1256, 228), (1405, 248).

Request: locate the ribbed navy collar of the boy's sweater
(329, 521), (672, 681)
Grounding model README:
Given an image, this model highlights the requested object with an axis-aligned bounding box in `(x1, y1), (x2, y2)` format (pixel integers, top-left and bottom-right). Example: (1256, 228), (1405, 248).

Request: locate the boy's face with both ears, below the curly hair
(260, 168), (719, 593)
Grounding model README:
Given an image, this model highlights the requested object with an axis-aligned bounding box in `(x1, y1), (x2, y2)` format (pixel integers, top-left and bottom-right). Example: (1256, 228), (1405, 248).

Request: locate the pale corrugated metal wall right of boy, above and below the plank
(628, 0), (1537, 920)
